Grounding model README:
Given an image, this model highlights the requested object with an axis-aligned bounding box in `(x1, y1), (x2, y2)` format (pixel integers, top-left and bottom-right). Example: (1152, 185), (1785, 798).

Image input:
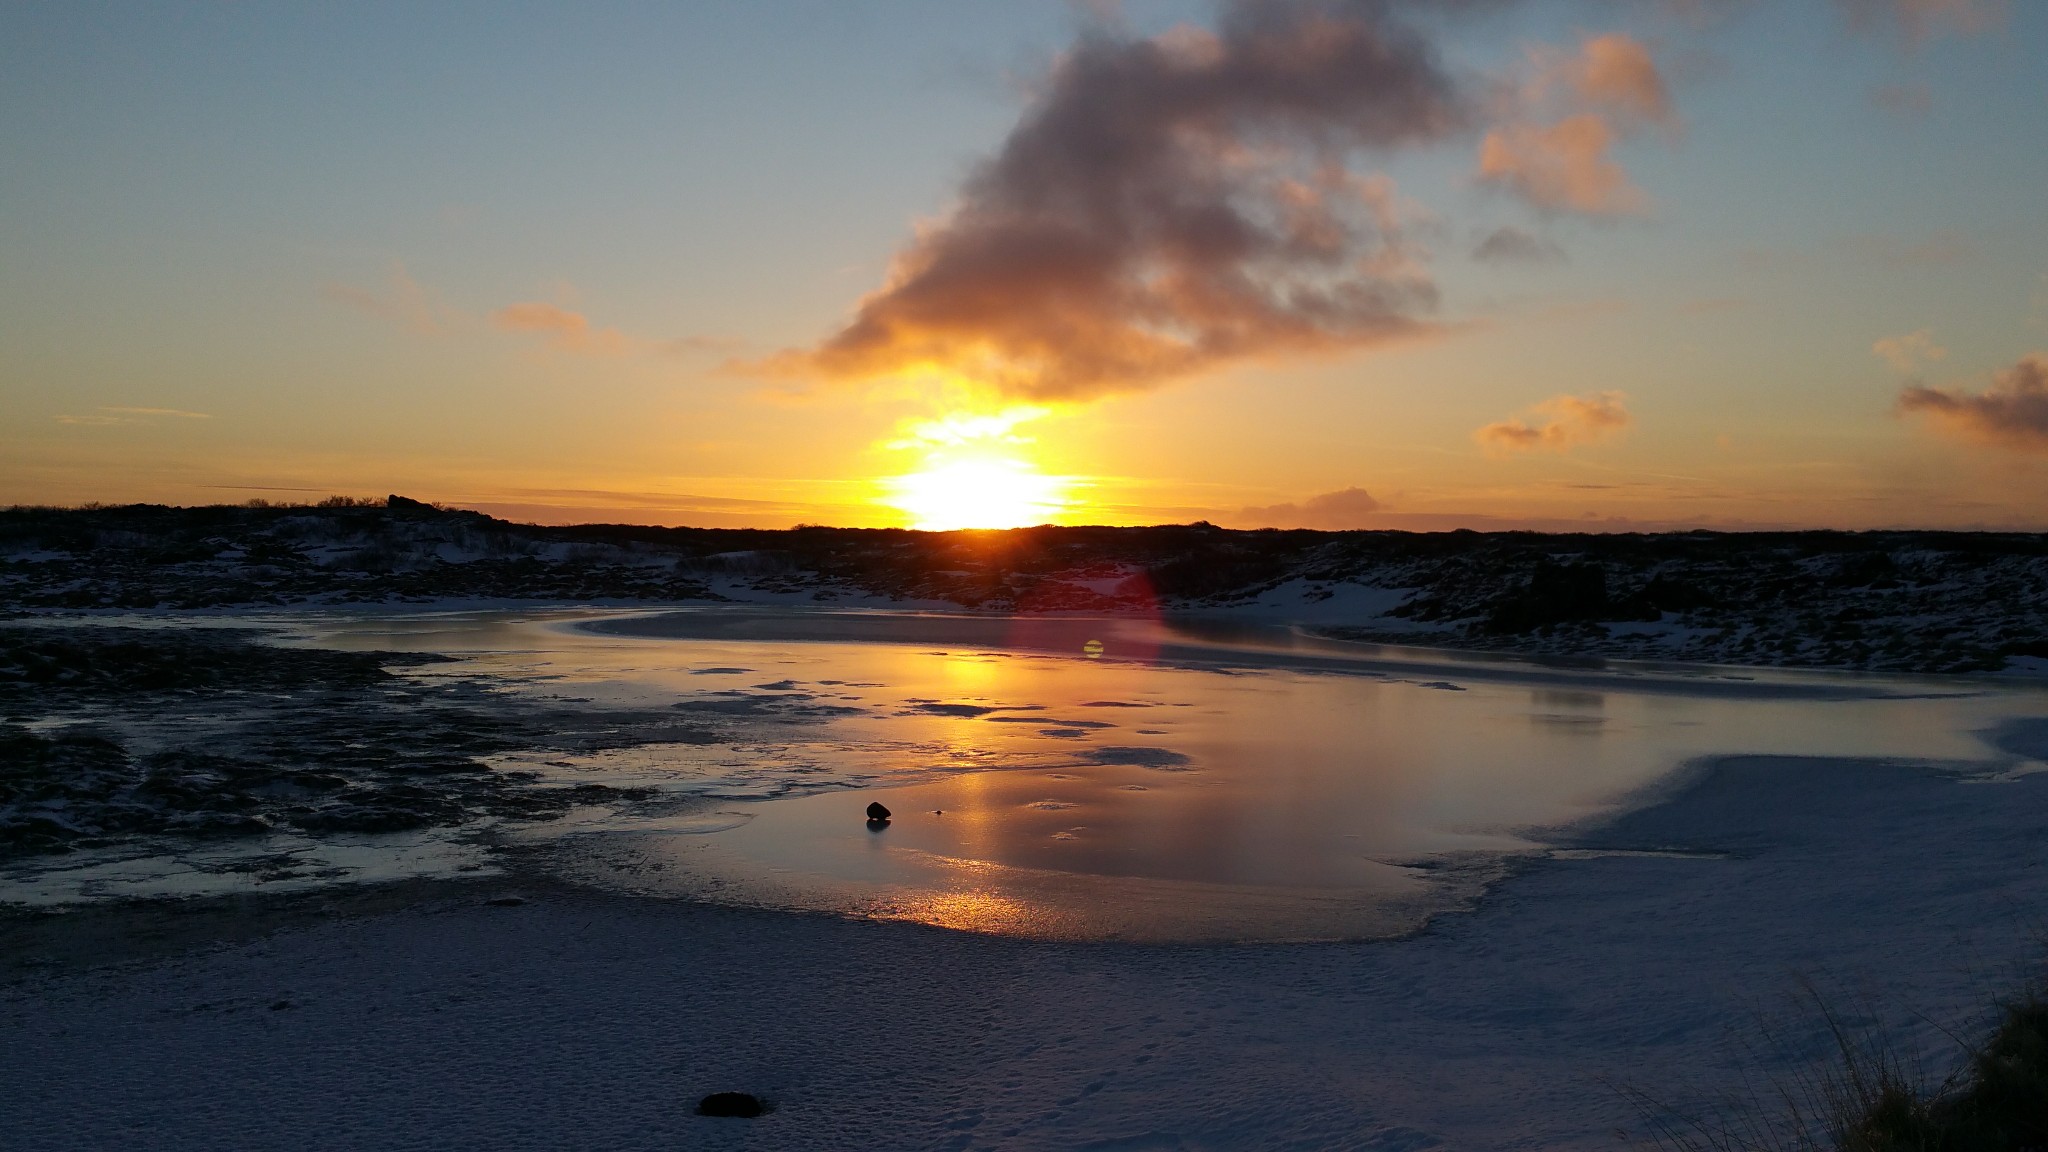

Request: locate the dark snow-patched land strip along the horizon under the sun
(0, 496), (2048, 672)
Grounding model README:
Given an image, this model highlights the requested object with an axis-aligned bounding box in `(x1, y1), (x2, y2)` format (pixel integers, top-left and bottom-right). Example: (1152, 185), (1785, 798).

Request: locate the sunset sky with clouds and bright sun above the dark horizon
(0, 0), (2048, 531)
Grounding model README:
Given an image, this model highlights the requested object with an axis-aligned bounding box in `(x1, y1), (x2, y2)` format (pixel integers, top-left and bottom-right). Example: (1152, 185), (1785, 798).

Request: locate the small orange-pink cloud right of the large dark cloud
(1479, 33), (1679, 215)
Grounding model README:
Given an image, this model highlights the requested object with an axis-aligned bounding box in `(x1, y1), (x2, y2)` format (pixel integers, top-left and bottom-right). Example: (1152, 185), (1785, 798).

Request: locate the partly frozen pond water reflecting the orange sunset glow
(8, 609), (2048, 941)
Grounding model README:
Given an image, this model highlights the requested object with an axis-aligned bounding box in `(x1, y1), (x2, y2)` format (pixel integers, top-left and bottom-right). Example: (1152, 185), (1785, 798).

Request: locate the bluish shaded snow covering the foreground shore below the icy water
(0, 758), (2048, 1150)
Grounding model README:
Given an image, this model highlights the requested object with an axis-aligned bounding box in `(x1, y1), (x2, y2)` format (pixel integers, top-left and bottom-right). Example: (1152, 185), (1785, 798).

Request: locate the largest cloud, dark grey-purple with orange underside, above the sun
(752, 0), (1470, 402)
